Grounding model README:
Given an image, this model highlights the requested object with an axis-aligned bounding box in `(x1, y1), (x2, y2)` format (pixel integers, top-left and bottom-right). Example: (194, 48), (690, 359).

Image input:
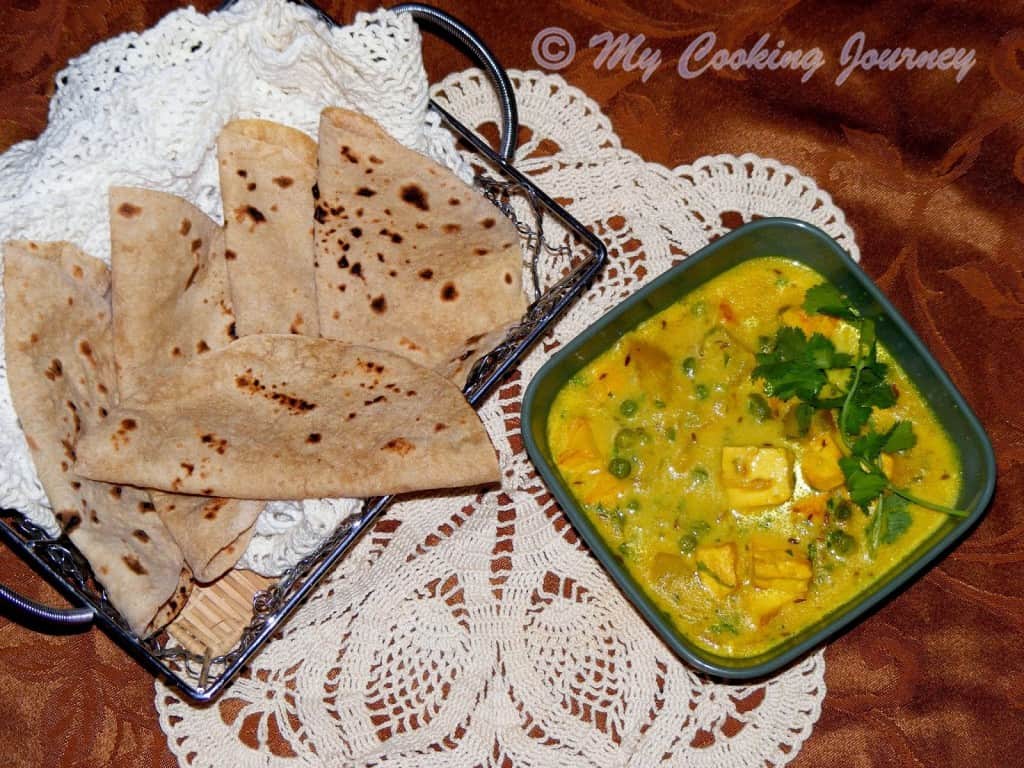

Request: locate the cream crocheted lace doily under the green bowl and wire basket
(156, 58), (859, 768)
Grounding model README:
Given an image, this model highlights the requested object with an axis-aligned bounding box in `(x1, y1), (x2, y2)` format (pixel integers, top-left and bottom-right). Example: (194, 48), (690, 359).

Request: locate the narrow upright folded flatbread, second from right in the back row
(217, 120), (319, 336)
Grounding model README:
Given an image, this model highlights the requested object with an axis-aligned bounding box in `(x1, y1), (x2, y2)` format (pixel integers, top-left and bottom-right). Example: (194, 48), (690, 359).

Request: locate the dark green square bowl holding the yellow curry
(522, 218), (995, 680)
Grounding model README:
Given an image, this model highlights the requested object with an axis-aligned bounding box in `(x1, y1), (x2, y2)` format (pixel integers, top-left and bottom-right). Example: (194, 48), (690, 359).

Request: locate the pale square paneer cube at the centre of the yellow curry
(722, 445), (793, 509)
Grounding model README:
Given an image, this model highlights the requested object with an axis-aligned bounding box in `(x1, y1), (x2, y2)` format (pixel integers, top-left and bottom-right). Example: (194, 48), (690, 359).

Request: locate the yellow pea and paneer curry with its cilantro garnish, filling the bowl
(544, 256), (966, 659)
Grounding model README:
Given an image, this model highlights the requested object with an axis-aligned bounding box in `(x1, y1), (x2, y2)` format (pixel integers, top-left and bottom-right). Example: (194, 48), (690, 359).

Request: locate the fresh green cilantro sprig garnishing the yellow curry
(752, 283), (967, 553)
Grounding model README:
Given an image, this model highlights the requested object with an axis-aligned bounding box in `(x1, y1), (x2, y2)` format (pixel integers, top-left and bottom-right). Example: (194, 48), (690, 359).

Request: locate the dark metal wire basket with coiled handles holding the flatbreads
(0, 2), (607, 701)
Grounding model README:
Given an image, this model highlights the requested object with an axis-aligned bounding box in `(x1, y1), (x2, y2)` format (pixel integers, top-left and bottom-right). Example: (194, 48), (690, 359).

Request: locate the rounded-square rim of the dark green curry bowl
(520, 217), (995, 680)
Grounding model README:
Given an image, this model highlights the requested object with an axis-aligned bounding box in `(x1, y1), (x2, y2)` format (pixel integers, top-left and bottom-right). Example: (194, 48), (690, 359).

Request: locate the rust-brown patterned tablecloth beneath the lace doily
(0, 0), (1024, 768)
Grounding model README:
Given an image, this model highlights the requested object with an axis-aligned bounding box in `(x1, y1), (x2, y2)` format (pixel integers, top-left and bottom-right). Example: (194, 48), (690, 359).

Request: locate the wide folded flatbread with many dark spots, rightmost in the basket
(314, 109), (526, 376)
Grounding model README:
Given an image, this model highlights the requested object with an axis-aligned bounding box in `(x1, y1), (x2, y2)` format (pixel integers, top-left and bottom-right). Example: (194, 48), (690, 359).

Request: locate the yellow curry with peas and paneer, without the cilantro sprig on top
(548, 257), (959, 657)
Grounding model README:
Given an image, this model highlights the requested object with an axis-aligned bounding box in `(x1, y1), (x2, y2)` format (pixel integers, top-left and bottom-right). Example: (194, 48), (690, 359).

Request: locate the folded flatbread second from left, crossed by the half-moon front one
(111, 187), (263, 582)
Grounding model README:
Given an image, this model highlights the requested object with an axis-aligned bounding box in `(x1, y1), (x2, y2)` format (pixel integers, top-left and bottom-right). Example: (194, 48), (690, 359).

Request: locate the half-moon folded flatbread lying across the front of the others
(76, 335), (500, 499)
